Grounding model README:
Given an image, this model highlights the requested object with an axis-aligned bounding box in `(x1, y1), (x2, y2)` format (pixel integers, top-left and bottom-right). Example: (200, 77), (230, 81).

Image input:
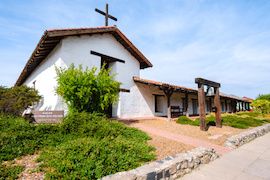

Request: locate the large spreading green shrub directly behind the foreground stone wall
(39, 137), (155, 179)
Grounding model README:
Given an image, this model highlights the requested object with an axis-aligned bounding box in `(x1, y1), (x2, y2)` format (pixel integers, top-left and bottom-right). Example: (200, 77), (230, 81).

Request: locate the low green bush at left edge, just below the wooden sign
(0, 115), (65, 164)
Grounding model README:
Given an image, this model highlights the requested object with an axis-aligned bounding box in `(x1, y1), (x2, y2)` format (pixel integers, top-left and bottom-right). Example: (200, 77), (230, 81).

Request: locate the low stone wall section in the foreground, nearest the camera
(102, 147), (218, 180)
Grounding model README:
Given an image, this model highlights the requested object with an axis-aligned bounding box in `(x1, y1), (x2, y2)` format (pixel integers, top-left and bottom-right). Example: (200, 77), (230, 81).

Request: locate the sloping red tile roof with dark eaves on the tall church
(15, 26), (153, 86)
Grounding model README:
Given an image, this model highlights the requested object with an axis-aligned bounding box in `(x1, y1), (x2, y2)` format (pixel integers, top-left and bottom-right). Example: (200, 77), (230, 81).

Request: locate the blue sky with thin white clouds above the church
(0, 0), (270, 98)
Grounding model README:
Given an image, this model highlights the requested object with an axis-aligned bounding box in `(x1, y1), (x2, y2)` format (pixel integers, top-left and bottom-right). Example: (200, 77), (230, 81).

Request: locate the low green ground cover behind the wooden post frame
(176, 112), (270, 129)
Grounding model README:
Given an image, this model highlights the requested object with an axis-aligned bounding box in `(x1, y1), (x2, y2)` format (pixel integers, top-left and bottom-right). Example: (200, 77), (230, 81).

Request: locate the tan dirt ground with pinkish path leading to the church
(127, 119), (243, 156)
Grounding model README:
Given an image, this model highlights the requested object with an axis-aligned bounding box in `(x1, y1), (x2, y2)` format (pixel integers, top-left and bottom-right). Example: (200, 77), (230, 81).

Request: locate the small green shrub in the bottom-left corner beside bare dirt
(0, 164), (24, 180)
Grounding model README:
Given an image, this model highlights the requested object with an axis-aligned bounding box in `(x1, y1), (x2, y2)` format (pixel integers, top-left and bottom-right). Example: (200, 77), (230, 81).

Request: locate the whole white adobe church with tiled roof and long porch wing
(16, 26), (250, 119)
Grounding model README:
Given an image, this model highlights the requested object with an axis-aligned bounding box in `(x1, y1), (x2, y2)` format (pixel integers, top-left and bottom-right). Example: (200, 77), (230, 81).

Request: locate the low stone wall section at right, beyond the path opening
(224, 124), (270, 149)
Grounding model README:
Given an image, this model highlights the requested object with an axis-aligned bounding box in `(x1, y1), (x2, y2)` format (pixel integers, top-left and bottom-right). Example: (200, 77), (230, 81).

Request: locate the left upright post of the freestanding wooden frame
(198, 84), (207, 131)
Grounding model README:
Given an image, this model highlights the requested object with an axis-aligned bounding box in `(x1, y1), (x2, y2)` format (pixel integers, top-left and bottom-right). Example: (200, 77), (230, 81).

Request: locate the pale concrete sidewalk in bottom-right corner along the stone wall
(181, 133), (270, 180)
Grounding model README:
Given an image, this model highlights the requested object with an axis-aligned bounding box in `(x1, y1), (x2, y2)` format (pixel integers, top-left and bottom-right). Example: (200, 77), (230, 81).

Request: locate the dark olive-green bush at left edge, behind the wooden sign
(0, 86), (41, 116)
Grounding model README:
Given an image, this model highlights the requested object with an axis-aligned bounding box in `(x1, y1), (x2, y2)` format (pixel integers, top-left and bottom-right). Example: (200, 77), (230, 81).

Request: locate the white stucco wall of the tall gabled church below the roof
(23, 34), (140, 117)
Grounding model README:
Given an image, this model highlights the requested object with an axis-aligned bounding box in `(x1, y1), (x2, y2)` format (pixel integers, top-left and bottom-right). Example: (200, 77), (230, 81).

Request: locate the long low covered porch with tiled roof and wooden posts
(133, 77), (250, 119)
